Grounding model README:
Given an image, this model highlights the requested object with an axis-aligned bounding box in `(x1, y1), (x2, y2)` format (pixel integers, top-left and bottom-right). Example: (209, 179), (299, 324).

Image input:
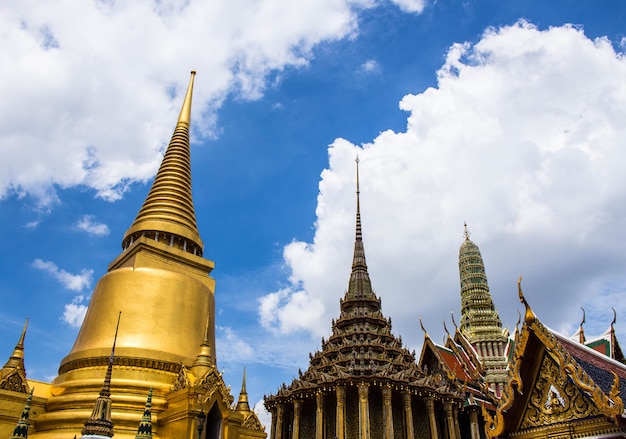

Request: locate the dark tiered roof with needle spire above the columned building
(266, 158), (458, 403)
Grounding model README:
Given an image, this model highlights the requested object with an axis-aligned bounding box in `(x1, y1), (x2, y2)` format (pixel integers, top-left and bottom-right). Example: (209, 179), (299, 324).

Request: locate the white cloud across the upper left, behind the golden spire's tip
(0, 0), (420, 207)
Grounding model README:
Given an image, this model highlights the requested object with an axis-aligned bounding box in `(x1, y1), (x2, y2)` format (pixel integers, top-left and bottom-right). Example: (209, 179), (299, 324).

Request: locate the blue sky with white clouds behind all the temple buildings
(0, 0), (626, 426)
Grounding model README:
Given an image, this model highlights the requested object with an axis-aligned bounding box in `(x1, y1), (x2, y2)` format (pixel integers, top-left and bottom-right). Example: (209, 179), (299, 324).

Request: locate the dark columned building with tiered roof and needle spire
(265, 159), (464, 439)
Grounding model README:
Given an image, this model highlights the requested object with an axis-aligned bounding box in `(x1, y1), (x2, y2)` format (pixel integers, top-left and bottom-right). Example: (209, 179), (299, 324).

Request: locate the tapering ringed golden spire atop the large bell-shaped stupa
(122, 71), (204, 256)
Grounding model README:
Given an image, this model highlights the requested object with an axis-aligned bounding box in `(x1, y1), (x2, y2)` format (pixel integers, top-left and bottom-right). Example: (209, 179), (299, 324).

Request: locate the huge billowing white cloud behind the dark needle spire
(259, 22), (626, 354)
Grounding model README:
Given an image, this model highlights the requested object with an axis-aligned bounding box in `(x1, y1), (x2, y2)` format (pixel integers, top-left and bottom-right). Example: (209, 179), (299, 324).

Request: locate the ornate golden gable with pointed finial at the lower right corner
(483, 278), (626, 438)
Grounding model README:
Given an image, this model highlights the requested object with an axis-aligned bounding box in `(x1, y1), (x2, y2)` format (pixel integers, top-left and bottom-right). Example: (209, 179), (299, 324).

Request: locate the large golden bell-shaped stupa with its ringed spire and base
(0, 72), (266, 439)
